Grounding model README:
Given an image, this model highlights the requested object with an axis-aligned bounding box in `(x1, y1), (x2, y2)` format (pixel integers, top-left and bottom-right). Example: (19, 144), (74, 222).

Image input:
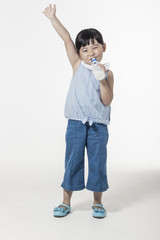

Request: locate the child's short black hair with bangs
(75, 28), (104, 53)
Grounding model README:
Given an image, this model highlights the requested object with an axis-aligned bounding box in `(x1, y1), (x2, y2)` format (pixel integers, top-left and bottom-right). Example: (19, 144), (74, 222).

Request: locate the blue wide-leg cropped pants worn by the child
(61, 119), (109, 192)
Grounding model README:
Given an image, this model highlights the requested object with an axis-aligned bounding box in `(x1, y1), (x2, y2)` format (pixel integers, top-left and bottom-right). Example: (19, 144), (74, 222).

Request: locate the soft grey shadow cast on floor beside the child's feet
(74, 171), (160, 212)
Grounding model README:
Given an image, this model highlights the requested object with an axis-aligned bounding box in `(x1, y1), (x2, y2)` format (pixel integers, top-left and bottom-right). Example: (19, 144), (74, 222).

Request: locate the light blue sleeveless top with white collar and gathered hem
(64, 60), (111, 126)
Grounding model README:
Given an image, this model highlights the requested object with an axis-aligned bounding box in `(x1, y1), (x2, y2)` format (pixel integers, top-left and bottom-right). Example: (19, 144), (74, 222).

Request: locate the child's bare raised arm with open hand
(42, 4), (80, 69)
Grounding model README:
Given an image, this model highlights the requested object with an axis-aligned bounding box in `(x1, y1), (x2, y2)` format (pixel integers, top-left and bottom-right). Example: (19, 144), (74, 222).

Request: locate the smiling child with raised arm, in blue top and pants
(43, 4), (114, 218)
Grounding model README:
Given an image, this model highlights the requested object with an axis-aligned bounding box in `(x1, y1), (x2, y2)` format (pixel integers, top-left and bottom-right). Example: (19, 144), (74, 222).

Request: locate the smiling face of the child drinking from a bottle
(79, 39), (106, 65)
